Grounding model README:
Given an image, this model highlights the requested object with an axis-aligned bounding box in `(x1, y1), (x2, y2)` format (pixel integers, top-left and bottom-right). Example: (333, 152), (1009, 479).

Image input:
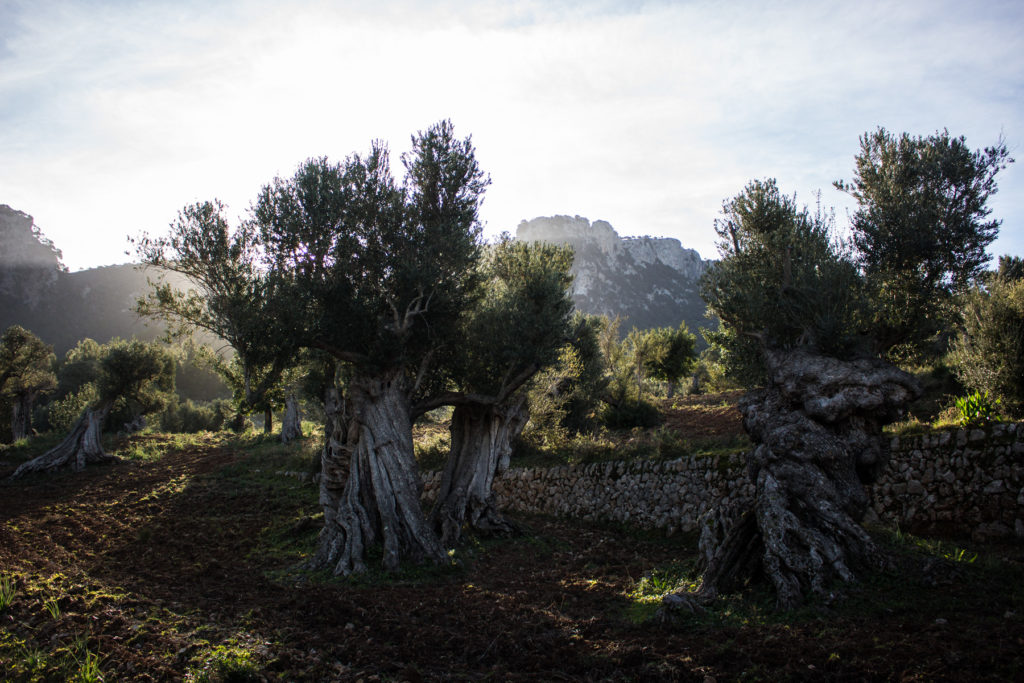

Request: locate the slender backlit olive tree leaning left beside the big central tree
(135, 200), (296, 432)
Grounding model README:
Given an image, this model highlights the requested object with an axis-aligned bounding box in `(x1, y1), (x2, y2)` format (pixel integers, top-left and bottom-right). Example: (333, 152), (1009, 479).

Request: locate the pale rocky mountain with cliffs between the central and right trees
(516, 216), (711, 332)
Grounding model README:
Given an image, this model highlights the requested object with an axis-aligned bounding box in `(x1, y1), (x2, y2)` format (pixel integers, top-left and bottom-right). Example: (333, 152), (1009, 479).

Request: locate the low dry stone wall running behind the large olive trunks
(424, 423), (1024, 539)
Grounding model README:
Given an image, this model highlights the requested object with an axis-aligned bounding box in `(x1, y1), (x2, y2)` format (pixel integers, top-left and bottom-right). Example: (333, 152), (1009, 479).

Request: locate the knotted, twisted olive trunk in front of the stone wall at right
(665, 350), (921, 610)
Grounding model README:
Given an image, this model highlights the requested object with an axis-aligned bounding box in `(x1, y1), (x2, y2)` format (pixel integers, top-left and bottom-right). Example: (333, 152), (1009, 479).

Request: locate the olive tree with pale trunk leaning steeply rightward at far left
(11, 339), (174, 478)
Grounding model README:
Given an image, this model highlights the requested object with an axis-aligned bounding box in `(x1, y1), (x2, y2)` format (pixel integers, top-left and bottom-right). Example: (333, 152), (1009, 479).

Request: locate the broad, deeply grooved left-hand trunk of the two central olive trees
(312, 371), (444, 575)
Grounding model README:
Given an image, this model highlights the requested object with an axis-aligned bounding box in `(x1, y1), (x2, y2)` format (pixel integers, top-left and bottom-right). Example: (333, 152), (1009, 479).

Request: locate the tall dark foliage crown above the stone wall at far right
(835, 128), (1013, 357)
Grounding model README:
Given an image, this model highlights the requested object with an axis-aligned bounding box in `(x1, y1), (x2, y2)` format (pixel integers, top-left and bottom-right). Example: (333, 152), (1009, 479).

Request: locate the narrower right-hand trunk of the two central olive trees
(431, 394), (528, 548)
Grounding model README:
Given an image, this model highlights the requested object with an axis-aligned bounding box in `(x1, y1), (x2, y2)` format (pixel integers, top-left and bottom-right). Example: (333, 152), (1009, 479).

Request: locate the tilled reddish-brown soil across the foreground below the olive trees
(0, 423), (1024, 682)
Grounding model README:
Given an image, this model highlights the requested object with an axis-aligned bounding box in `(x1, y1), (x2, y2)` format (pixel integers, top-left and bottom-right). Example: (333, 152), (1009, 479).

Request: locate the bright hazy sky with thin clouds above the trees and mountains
(0, 0), (1024, 270)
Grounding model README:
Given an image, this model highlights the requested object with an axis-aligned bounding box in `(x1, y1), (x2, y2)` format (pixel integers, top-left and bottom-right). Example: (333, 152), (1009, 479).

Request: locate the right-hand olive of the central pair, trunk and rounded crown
(424, 239), (572, 547)
